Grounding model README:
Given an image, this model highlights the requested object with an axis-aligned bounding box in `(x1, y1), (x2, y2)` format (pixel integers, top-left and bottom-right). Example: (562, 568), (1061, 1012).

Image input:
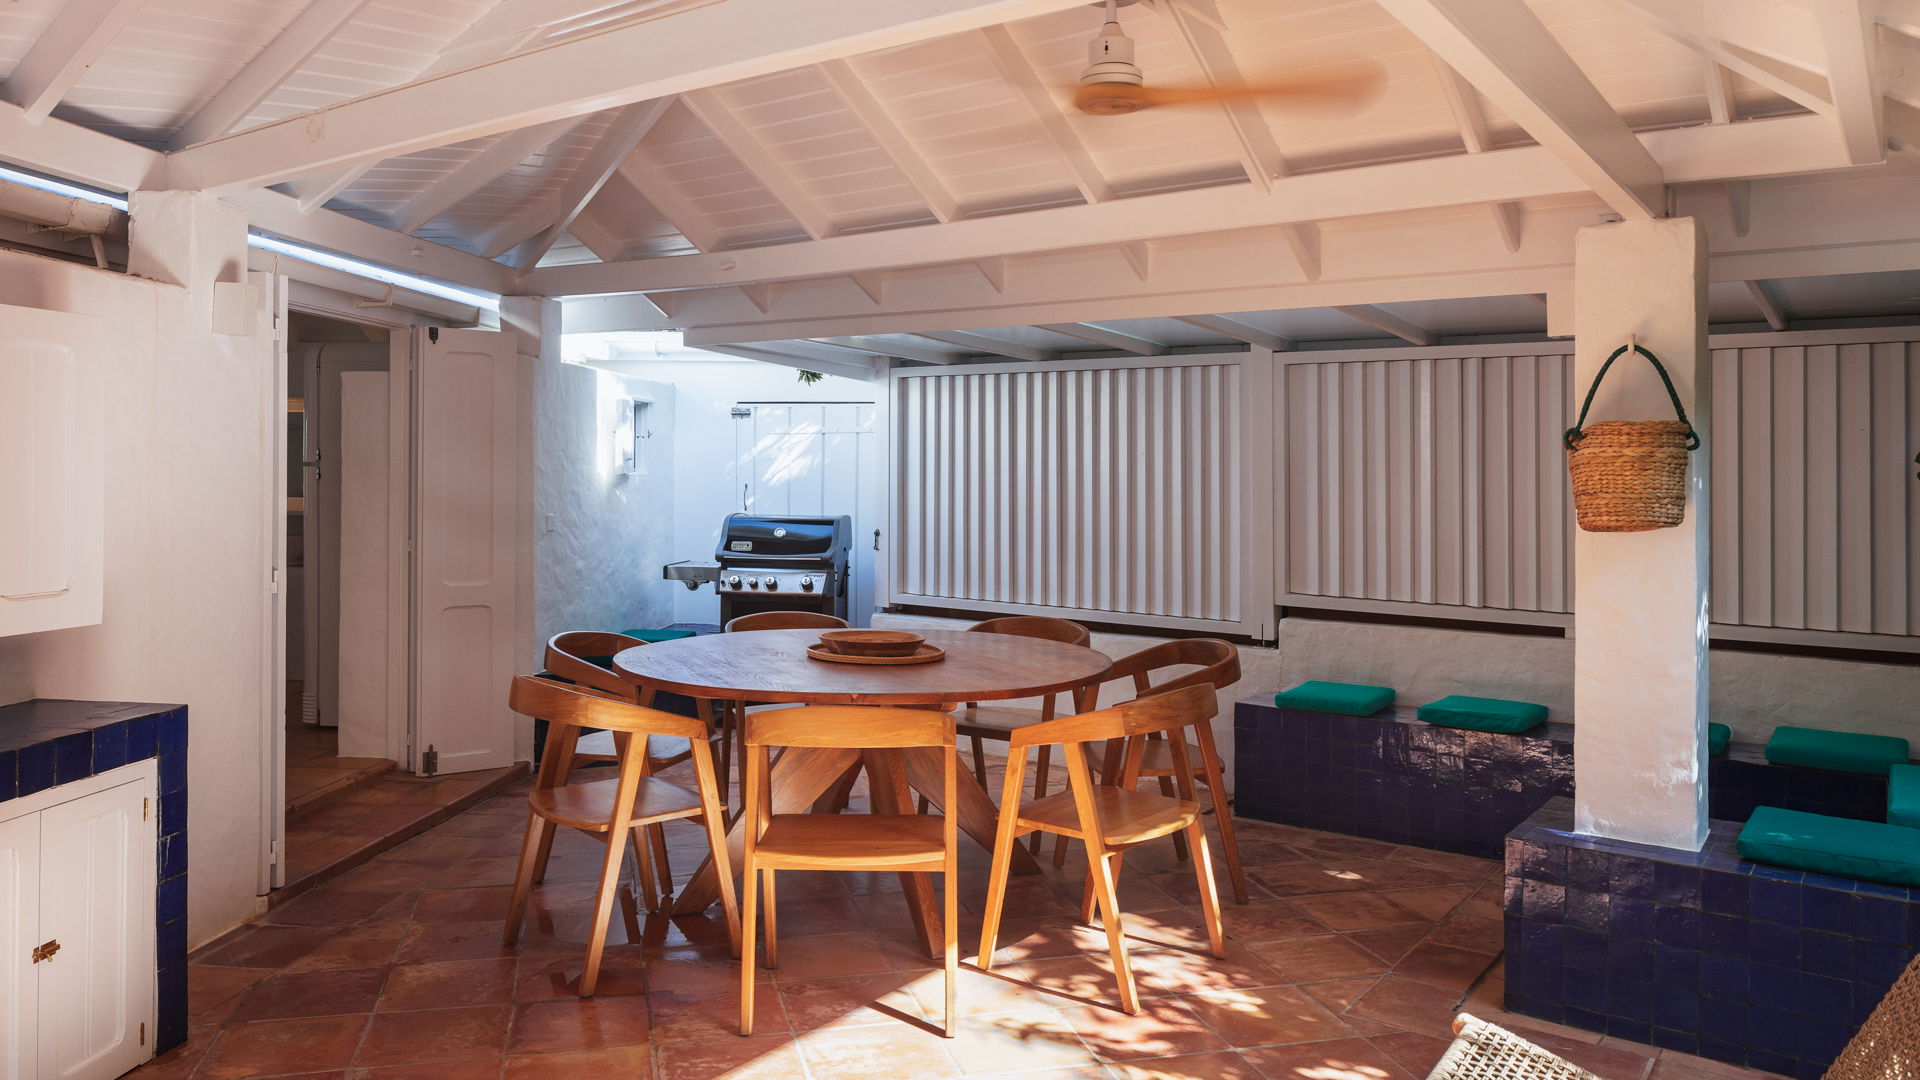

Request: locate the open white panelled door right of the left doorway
(403, 329), (526, 773)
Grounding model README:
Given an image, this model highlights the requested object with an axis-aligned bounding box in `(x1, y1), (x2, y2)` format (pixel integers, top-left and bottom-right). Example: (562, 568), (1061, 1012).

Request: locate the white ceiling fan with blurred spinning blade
(1073, 0), (1384, 115)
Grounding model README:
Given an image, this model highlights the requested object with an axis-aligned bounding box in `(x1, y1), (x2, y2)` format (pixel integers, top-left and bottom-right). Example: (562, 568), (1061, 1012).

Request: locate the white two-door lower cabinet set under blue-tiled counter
(0, 761), (157, 1080)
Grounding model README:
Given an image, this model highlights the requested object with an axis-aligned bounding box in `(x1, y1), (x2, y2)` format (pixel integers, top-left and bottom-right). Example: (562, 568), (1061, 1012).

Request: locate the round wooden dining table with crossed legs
(612, 630), (1114, 922)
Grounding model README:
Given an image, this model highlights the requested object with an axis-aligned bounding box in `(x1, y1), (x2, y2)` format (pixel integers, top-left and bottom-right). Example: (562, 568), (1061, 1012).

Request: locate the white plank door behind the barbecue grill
(733, 402), (883, 626)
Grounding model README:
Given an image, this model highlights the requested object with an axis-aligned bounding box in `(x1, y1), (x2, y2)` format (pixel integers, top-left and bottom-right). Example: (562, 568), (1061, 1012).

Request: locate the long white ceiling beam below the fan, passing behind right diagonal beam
(528, 115), (1847, 296)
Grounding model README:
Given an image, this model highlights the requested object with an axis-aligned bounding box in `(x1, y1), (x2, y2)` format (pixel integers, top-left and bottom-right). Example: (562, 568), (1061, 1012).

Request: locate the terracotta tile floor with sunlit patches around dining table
(134, 753), (1781, 1080)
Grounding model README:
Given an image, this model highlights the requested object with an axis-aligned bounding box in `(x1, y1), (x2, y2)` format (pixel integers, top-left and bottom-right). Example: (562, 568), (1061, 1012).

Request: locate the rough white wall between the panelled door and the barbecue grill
(534, 350), (685, 642)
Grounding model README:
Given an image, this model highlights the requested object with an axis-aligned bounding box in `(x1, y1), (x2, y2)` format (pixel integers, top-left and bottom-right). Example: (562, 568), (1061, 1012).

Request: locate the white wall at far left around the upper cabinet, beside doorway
(0, 192), (272, 944)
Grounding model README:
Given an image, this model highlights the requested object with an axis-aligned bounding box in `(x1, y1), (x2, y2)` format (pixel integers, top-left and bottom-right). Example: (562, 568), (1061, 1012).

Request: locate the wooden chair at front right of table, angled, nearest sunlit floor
(979, 686), (1227, 1013)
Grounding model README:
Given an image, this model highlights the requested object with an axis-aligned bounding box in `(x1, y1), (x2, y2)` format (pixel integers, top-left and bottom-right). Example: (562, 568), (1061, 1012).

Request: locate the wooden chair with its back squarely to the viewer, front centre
(739, 705), (960, 1038)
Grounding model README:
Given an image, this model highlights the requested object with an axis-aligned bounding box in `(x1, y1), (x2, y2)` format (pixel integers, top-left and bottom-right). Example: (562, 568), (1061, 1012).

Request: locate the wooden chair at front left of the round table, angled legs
(501, 675), (739, 997)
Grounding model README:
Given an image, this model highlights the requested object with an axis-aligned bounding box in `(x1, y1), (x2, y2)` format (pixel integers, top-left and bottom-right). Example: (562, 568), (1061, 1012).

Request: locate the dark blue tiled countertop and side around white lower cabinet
(0, 698), (186, 1053)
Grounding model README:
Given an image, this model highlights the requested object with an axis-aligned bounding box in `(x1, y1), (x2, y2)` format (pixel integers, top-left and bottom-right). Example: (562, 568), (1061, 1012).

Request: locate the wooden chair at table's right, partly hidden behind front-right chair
(1054, 638), (1248, 903)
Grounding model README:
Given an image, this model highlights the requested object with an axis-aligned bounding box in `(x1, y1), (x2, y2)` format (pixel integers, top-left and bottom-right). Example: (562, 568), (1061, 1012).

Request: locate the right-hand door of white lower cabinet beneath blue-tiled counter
(38, 780), (154, 1080)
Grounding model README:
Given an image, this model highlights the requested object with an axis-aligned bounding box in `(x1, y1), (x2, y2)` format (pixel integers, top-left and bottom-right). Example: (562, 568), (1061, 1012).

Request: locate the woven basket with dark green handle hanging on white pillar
(1567, 344), (1699, 532)
